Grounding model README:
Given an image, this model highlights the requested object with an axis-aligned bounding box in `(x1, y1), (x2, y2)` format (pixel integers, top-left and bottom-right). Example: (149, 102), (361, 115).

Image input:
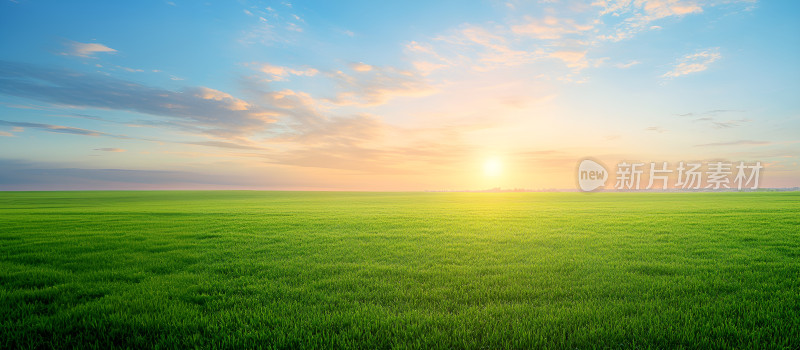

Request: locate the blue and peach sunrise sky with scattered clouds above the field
(0, 0), (800, 191)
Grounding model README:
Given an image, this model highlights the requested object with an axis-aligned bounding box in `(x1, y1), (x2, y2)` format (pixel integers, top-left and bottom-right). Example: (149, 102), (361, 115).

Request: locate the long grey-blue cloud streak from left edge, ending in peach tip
(0, 61), (282, 137)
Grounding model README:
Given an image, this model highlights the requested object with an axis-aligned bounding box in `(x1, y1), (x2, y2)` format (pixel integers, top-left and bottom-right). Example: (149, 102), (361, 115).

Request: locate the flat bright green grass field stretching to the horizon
(0, 192), (800, 349)
